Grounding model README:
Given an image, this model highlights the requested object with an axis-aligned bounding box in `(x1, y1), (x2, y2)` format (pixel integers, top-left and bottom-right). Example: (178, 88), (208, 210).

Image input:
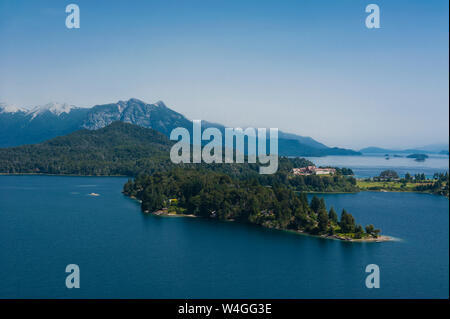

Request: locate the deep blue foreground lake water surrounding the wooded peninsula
(0, 176), (449, 298)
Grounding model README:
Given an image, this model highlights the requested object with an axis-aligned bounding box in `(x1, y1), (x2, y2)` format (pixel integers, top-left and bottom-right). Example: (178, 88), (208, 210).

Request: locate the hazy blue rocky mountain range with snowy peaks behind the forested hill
(0, 98), (361, 156)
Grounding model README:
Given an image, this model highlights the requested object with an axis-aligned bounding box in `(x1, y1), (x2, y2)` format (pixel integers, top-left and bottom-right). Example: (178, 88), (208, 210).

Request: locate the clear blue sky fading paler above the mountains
(0, 0), (449, 149)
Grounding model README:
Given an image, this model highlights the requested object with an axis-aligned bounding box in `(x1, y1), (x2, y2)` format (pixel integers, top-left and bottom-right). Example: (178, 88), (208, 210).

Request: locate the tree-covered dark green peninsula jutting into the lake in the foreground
(123, 169), (391, 242)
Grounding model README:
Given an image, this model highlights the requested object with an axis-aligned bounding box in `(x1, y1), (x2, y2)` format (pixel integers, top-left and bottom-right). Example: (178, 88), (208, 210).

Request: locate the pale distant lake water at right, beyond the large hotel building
(307, 154), (449, 178)
